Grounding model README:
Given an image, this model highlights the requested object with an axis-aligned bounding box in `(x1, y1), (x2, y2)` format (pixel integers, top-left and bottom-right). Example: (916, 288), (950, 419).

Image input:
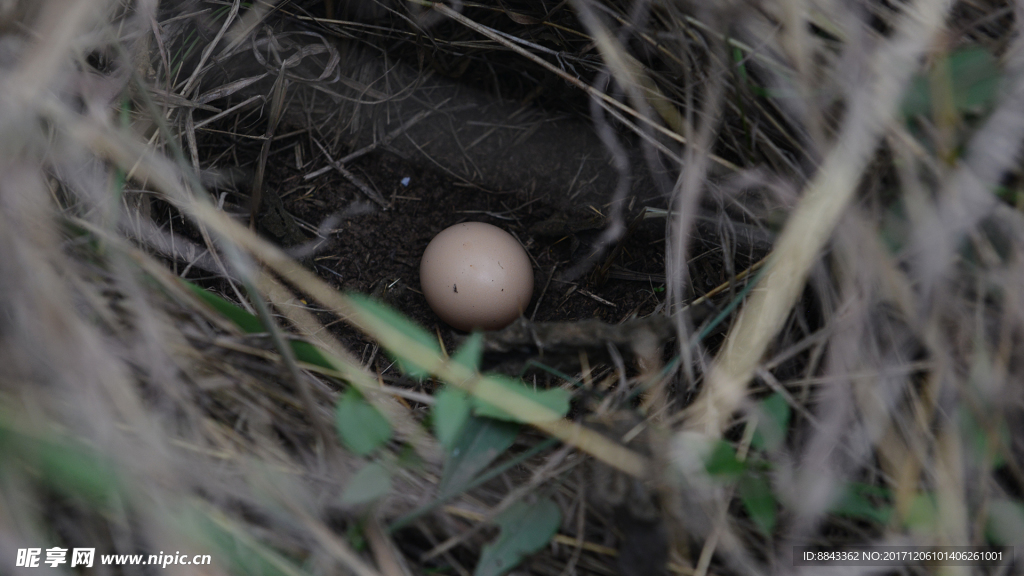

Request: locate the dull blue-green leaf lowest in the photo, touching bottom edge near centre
(473, 498), (562, 576)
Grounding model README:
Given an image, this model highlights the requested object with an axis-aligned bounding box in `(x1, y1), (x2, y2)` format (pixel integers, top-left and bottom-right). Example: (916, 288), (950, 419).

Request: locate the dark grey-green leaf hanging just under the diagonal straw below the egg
(438, 416), (519, 494)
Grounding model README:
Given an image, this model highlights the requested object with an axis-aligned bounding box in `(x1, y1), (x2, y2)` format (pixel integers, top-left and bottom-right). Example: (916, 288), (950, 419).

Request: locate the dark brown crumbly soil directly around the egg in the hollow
(267, 129), (665, 356)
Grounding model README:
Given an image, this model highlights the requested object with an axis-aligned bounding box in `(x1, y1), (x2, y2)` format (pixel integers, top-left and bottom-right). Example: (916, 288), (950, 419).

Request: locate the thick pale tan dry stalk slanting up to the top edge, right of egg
(686, 0), (951, 437)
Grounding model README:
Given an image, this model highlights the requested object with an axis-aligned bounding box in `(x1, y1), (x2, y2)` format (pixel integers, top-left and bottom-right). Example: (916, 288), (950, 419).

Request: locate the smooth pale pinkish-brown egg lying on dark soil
(420, 222), (534, 332)
